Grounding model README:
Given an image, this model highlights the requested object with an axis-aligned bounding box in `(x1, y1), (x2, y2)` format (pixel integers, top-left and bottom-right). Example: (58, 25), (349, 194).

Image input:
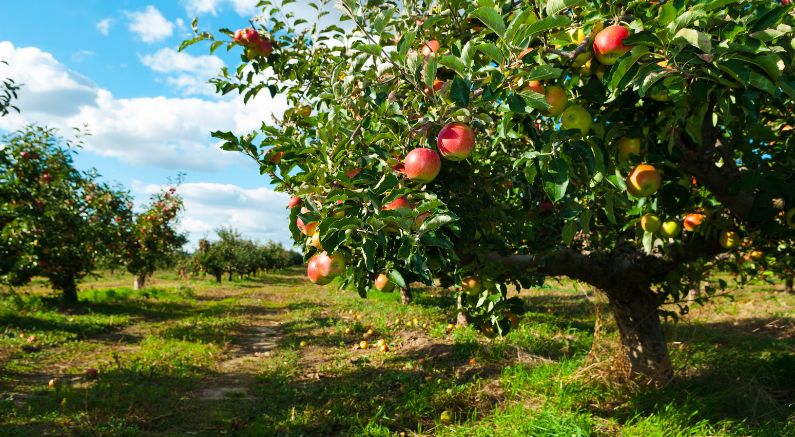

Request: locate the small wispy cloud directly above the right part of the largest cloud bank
(141, 48), (224, 96)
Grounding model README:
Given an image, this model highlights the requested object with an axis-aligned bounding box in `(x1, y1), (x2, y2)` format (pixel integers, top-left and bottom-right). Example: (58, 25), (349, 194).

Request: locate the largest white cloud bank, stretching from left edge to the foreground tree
(0, 42), (287, 171)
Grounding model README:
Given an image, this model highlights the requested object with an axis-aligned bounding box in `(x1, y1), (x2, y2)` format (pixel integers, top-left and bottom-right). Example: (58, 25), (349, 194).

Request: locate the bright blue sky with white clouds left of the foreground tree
(0, 0), (336, 244)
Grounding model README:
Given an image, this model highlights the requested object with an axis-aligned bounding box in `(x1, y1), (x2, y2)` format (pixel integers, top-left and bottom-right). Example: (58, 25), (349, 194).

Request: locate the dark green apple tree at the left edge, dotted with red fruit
(0, 126), (132, 303)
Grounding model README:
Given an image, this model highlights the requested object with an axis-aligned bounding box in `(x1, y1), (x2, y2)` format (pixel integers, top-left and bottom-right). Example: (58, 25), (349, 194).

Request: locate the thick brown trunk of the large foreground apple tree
(607, 288), (673, 385)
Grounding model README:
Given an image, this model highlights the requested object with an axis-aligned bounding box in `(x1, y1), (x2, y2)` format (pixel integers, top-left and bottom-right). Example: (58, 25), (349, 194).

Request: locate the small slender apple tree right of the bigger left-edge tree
(125, 187), (188, 290)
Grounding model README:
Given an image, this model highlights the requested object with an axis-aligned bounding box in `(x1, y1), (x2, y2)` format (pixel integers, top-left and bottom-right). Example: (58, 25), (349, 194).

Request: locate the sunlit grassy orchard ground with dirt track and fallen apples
(0, 269), (795, 436)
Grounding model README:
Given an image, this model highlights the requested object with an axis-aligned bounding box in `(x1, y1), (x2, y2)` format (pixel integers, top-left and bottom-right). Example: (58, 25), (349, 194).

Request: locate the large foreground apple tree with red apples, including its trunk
(188, 0), (795, 383)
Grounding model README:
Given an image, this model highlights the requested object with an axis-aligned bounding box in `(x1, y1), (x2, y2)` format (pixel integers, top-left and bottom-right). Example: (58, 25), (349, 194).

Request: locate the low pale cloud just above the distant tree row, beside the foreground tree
(134, 182), (293, 248)
